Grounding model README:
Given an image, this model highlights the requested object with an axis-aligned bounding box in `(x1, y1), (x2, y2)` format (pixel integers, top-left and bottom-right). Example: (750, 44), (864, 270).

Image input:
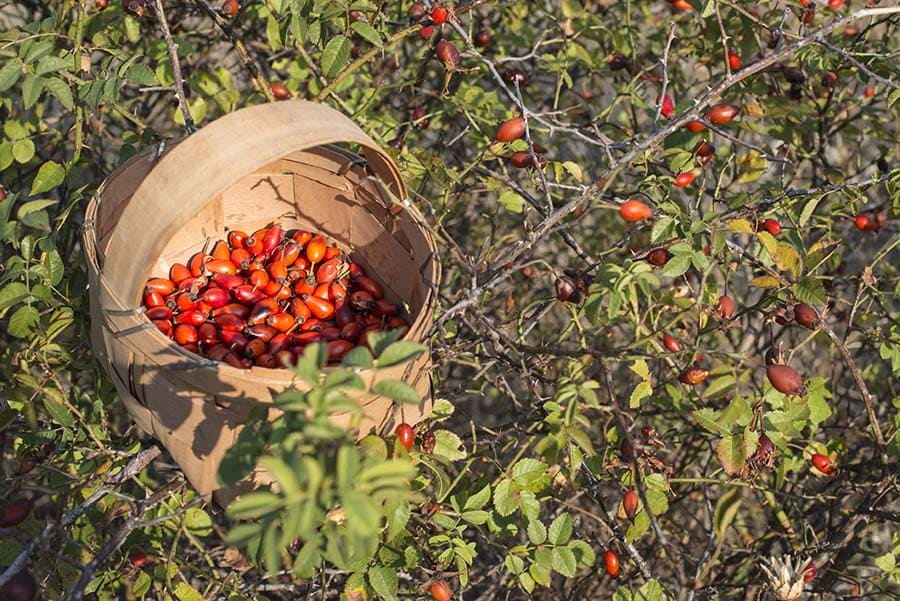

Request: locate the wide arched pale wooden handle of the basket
(103, 100), (406, 309)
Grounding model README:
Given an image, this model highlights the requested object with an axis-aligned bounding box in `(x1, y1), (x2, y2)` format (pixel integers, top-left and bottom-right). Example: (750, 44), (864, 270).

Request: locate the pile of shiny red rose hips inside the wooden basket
(143, 223), (409, 369)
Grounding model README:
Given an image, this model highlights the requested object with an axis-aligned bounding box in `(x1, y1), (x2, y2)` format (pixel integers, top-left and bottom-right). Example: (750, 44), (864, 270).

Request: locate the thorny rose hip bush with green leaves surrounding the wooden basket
(0, 0), (900, 601)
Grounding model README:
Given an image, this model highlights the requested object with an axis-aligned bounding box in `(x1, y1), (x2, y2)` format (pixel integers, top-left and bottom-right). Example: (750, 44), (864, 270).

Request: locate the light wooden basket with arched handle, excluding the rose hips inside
(83, 101), (440, 501)
